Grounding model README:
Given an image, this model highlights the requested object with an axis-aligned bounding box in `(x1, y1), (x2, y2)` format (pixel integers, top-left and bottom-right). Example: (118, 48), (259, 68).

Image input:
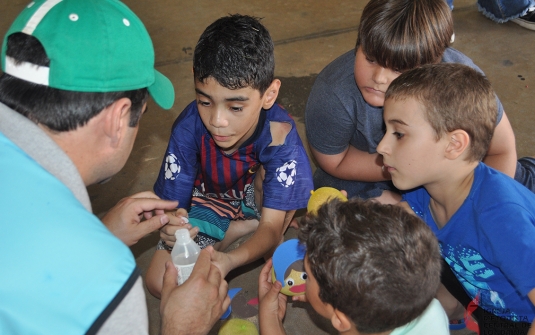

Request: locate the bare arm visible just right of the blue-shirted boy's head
(483, 112), (517, 178)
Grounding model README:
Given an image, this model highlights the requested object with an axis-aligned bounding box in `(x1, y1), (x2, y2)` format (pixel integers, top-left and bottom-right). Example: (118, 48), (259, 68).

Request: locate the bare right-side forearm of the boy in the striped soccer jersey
(214, 207), (295, 277)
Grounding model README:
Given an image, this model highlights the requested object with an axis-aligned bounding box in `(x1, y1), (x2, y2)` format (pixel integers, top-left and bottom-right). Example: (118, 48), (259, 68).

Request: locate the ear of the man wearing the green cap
(102, 98), (132, 147)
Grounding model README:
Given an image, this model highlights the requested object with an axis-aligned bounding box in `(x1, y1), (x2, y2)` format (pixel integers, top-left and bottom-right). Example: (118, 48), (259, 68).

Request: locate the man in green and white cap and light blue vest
(0, 0), (230, 334)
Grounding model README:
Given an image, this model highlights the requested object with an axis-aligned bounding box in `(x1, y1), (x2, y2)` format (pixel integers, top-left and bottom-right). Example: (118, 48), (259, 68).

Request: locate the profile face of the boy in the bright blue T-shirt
(377, 98), (448, 190)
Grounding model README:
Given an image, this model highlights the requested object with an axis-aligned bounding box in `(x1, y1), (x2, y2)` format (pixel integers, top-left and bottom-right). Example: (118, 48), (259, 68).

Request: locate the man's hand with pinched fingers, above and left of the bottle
(102, 191), (178, 246)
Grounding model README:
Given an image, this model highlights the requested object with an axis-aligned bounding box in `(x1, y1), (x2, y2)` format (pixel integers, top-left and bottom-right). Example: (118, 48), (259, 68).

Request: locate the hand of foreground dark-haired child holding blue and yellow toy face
(258, 258), (287, 334)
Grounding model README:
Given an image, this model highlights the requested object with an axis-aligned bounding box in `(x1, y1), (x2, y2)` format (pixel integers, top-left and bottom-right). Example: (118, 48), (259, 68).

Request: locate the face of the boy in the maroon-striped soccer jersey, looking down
(195, 77), (266, 153)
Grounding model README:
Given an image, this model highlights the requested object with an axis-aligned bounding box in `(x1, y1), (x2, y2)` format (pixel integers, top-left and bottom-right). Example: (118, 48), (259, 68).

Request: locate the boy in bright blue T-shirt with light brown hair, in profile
(377, 64), (535, 334)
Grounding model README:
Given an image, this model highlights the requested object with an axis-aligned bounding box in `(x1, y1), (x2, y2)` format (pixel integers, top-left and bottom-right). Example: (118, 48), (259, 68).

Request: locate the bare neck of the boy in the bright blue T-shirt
(424, 162), (479, 228)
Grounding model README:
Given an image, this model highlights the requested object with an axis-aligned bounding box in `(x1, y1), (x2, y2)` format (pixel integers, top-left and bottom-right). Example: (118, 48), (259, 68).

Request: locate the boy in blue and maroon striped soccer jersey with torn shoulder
(146, 15), (313, 296)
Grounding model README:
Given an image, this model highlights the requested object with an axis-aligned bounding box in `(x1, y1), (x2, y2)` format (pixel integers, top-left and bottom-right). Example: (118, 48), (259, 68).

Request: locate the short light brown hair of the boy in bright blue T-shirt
(385, 63), (498, 161)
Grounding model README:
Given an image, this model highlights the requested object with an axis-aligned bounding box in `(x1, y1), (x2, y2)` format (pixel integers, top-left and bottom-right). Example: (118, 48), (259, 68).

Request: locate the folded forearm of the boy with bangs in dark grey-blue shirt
(310, 145), (391, 182)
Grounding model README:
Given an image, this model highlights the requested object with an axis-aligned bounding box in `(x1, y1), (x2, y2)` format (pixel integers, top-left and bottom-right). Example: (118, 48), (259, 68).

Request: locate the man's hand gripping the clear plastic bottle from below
(160, 246), (230, 335)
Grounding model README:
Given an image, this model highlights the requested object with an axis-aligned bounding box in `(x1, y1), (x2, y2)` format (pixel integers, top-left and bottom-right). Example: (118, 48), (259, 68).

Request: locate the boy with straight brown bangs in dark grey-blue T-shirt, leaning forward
(305, 0), (535, 202)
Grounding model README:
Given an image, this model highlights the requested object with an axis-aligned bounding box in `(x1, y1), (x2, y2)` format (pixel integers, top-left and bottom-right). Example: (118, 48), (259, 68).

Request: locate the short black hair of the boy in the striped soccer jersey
(193, 14), (275, 95)
